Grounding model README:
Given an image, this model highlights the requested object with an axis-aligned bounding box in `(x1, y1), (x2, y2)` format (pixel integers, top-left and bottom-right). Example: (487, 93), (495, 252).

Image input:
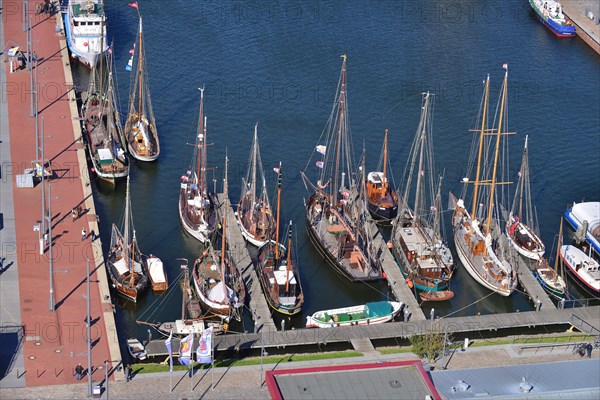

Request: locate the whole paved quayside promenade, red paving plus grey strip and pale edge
(0, 0), (120, 388)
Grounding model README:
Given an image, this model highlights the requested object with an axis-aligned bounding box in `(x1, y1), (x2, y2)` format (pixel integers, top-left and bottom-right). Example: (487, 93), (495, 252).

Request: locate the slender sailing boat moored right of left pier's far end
(235, 123), (275, 247)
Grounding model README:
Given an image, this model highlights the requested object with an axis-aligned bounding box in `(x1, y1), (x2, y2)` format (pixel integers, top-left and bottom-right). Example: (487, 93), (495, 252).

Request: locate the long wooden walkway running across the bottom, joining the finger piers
(146, 306), (600, 356)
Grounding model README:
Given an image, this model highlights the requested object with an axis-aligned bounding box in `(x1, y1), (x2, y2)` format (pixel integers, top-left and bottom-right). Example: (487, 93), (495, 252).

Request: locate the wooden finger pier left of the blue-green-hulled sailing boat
(368, 220), (427, 321)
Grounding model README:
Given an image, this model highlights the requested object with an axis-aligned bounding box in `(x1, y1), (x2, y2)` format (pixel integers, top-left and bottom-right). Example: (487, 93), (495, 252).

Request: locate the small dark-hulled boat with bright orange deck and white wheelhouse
(367, 129), (398, 220)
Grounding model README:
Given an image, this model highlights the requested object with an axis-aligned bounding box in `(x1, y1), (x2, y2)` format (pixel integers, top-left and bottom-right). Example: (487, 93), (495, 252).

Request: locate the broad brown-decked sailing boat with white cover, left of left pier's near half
(193, 158), (246, 321)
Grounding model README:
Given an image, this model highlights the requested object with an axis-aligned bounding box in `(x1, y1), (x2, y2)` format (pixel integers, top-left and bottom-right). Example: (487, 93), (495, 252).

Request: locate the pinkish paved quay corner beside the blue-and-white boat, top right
(561, 0), (600, 54)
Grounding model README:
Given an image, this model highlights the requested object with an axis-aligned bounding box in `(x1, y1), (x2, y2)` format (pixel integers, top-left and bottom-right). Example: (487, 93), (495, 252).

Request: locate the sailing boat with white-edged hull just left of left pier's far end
(179, 88), (216, 244)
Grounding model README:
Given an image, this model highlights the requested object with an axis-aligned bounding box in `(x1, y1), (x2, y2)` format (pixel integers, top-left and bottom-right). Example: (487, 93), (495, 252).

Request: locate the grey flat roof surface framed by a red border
(275, 366), (431, 400)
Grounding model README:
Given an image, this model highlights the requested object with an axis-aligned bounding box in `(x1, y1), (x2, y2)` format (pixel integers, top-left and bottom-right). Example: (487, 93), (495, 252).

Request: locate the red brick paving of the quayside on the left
(2, 0), (116, 386)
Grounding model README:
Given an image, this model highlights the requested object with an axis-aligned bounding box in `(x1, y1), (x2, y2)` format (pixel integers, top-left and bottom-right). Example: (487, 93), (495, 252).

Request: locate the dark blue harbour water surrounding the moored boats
(75, 0), (600, 337)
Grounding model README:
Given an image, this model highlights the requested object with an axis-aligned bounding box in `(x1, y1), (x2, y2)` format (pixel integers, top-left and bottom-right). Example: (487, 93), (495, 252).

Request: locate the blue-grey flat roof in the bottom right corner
(431, 358), (600, 400)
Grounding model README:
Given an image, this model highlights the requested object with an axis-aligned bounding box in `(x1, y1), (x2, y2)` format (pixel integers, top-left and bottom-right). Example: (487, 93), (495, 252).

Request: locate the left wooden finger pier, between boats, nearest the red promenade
(217, 193), (277, 332)
